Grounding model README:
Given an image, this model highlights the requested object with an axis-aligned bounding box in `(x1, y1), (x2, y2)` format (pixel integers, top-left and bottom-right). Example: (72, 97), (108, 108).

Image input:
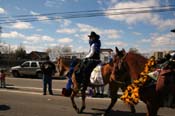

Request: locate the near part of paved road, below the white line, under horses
(0, 90), (148, 116)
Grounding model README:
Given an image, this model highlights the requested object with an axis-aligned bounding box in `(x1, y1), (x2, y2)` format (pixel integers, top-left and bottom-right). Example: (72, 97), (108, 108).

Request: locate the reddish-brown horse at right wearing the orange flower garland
(111, 48), (175, 116)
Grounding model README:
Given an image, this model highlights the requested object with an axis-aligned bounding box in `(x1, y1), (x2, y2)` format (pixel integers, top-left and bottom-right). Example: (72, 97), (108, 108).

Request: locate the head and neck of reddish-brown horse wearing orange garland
(111, 47), (147, 85)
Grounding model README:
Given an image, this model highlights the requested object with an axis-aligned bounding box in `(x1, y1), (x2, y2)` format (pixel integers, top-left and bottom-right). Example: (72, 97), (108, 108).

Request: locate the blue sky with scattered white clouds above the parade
(0, 0), (175, 53)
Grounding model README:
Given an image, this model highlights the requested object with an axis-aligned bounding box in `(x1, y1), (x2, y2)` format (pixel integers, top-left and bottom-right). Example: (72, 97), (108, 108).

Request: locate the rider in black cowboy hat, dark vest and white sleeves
(75, 31), (101, 88)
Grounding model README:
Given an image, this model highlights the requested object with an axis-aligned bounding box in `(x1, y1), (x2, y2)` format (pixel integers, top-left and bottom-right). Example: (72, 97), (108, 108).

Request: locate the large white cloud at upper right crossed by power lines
(105, 0), (175, 29)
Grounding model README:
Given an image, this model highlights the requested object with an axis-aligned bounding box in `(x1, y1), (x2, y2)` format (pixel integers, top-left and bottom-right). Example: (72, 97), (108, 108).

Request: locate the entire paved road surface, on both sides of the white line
(0, 78), (175, 116)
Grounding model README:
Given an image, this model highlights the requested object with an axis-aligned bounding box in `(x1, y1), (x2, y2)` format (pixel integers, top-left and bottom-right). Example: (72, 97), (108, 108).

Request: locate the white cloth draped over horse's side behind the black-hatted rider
(90, 64), (104, 85)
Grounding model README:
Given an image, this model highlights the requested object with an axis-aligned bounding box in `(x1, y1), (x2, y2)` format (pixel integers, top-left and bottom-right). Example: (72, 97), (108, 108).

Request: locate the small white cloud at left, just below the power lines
(10, 22), (33, 29)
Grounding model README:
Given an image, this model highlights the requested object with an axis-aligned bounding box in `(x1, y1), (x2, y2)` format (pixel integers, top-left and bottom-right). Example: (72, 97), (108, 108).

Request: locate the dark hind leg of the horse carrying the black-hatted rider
(105, 82), (118, 114)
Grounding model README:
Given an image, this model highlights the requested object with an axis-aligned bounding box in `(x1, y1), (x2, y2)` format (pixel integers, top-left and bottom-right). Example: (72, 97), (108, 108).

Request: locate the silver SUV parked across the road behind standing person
(10, 61), (43, 78)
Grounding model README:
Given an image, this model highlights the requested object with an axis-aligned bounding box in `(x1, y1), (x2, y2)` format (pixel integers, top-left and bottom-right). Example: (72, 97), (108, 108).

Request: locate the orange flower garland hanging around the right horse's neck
(120, 58), (155, 105)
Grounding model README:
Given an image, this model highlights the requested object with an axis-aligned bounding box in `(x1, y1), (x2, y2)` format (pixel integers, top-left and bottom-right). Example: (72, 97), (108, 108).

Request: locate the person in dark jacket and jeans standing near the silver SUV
(41, 56), (56, 95)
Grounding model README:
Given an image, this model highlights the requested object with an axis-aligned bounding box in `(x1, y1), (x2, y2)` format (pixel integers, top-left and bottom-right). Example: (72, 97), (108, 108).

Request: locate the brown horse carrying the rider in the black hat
(57, 57), (135, 114)
